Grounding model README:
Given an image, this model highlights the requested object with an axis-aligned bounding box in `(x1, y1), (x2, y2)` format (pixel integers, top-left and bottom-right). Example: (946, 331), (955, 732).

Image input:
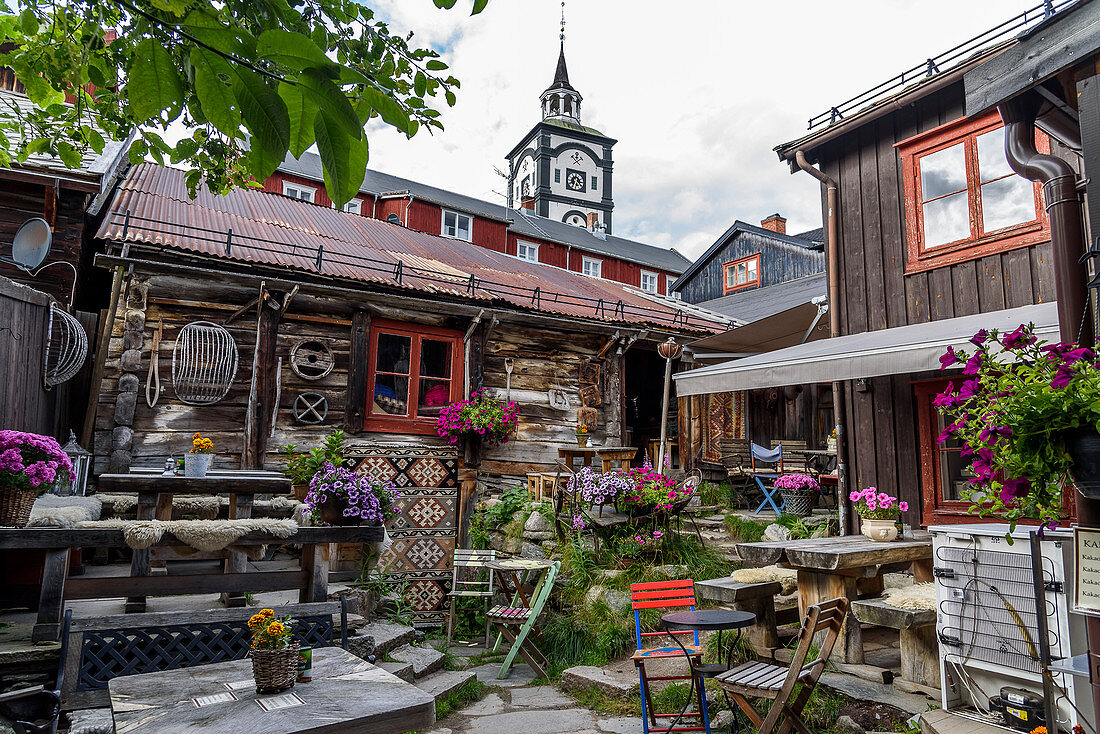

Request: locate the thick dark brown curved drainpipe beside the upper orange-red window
(997, 97), (1093, 346)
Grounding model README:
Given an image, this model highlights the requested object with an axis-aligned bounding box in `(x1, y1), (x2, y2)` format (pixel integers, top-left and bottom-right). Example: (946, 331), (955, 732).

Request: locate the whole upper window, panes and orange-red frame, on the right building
(897, 112), (1049, 273)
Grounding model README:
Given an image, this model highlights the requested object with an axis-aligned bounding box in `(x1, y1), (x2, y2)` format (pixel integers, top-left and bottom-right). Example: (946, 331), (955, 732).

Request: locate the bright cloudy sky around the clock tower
(369, 0), (1037, 259)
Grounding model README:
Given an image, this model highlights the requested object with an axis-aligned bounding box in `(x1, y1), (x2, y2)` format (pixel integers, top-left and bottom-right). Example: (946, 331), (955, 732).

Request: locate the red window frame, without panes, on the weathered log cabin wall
(363, 319), (465, 436)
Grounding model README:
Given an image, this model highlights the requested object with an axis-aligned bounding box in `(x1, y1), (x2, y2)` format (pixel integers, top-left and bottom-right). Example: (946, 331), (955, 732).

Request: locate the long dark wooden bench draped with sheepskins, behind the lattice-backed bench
(0, 525), (383, 642)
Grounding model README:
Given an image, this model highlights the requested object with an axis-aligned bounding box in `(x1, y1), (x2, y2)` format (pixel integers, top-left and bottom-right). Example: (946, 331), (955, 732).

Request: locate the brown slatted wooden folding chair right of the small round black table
(717, 598), (848, 734)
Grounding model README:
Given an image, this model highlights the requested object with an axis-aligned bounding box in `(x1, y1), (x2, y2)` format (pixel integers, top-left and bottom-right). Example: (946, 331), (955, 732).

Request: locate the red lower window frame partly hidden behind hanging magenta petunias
(913, 377), (1077, 526)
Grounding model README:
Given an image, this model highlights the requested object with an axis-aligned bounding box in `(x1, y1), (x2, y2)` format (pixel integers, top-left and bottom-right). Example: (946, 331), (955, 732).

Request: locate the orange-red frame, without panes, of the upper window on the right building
(894, 111), (1051, 273)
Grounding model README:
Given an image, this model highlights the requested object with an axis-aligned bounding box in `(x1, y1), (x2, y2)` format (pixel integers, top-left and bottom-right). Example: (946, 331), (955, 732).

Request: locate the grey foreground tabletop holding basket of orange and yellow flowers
(110, 647), (436, 734)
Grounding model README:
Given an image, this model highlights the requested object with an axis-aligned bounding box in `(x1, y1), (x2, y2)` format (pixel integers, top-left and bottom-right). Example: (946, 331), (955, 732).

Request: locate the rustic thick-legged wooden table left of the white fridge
(737, 532), (932, 665)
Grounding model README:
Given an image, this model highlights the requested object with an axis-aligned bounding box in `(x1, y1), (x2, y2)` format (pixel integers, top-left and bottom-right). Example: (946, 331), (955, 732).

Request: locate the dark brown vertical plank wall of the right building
(812, 81), (1077, 526)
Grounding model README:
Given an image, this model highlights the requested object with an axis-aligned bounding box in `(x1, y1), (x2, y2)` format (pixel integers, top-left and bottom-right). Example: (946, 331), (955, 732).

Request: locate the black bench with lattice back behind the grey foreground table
(61, 598), (348, 711)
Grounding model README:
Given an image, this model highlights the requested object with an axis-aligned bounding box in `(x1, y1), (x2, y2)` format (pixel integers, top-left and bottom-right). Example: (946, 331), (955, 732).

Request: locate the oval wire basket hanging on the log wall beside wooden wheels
(172, 321), (238, 405)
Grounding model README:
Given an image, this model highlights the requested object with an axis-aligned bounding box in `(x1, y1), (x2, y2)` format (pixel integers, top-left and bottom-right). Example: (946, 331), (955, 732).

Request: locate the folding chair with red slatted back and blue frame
(630, 579), (711, 734)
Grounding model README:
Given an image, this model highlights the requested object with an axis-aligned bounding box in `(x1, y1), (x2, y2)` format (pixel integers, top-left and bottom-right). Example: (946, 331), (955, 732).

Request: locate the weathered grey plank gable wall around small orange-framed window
(679, 226), (825, 301)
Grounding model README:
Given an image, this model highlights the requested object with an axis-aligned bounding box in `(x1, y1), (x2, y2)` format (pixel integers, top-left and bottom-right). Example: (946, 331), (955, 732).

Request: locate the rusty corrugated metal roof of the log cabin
(97, 164), (729, 331)
